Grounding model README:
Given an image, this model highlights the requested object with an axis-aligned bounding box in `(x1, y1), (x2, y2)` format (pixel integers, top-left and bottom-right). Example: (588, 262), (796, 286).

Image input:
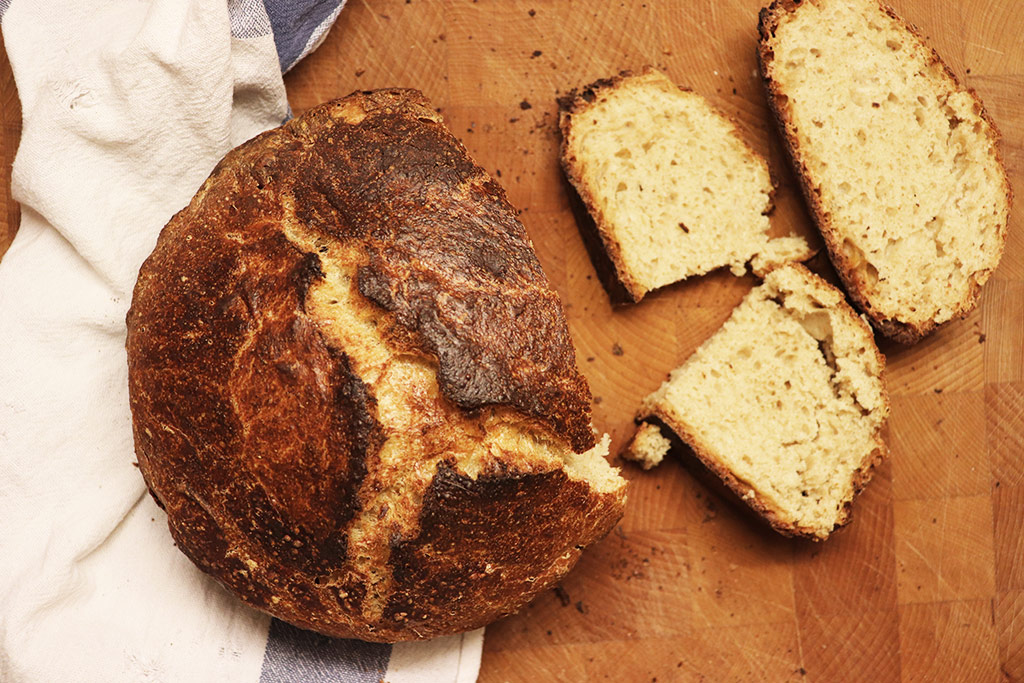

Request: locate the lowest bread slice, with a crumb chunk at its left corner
(624, 264), (889, 540)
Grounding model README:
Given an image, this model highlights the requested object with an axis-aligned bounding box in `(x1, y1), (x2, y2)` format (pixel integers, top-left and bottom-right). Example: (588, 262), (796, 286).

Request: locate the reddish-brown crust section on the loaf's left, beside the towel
(128, 160), (383, 607)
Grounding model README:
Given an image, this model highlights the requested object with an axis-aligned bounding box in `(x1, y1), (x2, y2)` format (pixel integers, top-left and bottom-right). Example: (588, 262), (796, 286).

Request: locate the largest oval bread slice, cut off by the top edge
(759, 0), (1011, 343)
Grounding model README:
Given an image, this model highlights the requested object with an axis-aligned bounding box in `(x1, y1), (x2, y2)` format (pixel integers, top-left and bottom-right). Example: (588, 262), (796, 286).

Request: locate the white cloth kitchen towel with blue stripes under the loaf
(0, 0), (482, 683)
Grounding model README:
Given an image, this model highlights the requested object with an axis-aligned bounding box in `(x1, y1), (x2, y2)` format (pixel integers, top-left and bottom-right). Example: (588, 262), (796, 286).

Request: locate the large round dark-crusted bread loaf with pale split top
(127, 90), (625, 641)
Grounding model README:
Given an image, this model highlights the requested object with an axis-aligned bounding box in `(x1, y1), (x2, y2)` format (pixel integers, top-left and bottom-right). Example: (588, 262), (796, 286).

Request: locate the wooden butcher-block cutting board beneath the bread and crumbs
(0, 0), (1024, 683)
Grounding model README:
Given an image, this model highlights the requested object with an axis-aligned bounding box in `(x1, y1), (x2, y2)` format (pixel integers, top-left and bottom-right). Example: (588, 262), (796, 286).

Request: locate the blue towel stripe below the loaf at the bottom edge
(259, 620), (391, 683)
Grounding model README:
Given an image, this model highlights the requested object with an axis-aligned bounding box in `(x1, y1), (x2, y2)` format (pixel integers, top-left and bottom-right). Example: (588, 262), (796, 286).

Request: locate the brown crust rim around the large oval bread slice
(758, 0), (1013, 344)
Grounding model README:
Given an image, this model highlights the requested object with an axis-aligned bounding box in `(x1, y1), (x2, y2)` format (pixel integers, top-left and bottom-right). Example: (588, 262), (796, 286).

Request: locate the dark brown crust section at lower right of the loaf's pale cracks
(384, 462), (620, 630)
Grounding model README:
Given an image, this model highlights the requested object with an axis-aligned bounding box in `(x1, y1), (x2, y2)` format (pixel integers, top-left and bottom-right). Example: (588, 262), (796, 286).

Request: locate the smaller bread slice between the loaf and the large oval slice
(559, 68), (812, 301)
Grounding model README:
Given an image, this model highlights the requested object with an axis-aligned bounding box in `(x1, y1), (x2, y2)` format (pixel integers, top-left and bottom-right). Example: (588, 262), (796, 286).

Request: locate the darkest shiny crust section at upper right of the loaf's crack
(293, 96), (594, 451)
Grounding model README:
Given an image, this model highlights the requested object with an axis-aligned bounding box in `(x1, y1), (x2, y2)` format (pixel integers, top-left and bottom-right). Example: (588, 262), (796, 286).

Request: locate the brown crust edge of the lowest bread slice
(637, 263), (891, 541)
